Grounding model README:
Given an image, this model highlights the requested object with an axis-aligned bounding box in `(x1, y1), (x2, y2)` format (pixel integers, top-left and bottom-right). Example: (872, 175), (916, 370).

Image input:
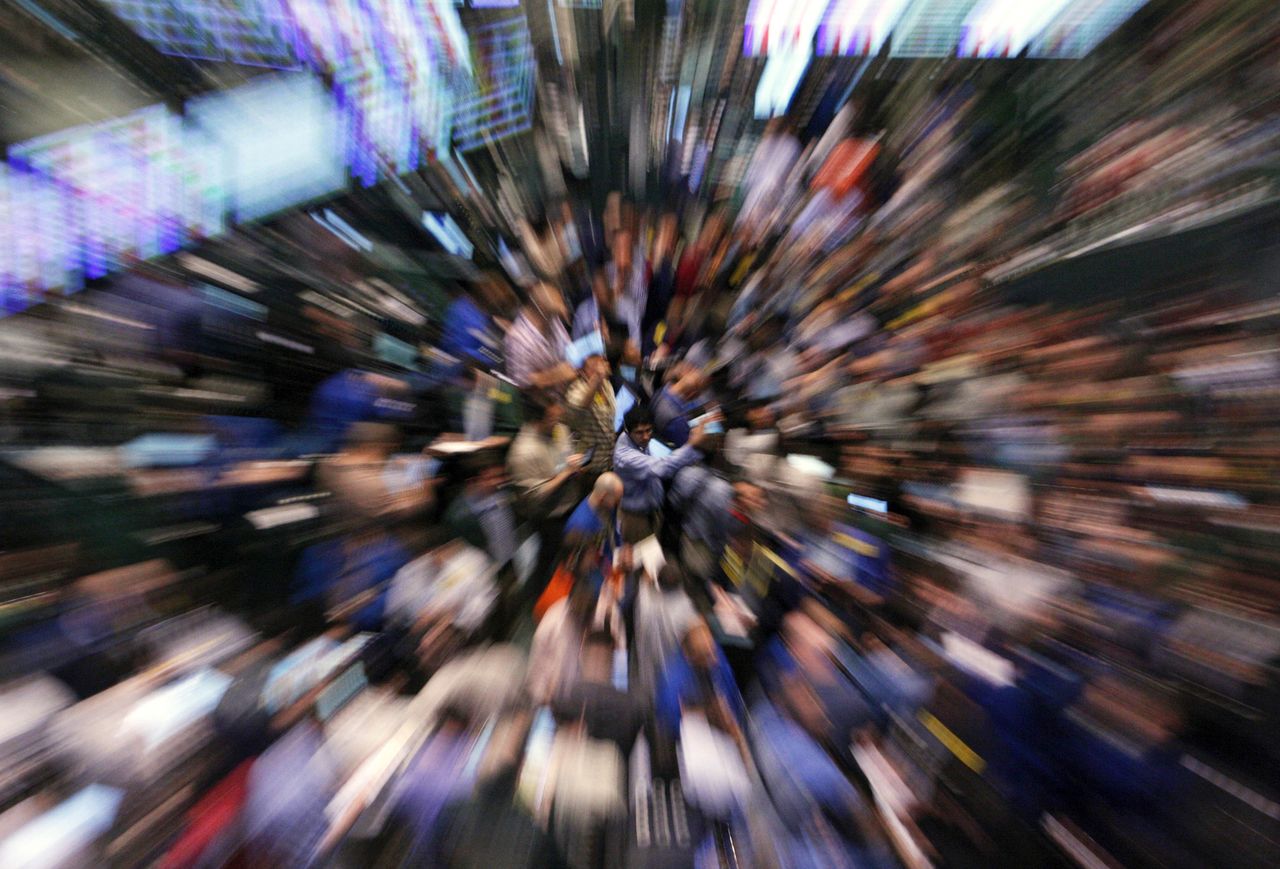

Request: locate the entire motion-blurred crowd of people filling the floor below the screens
(0, 0), (1280, 869)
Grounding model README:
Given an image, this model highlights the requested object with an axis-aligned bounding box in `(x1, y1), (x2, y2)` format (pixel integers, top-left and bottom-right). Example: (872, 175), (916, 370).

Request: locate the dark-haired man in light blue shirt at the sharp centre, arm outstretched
(613, 404), (708, 543)
